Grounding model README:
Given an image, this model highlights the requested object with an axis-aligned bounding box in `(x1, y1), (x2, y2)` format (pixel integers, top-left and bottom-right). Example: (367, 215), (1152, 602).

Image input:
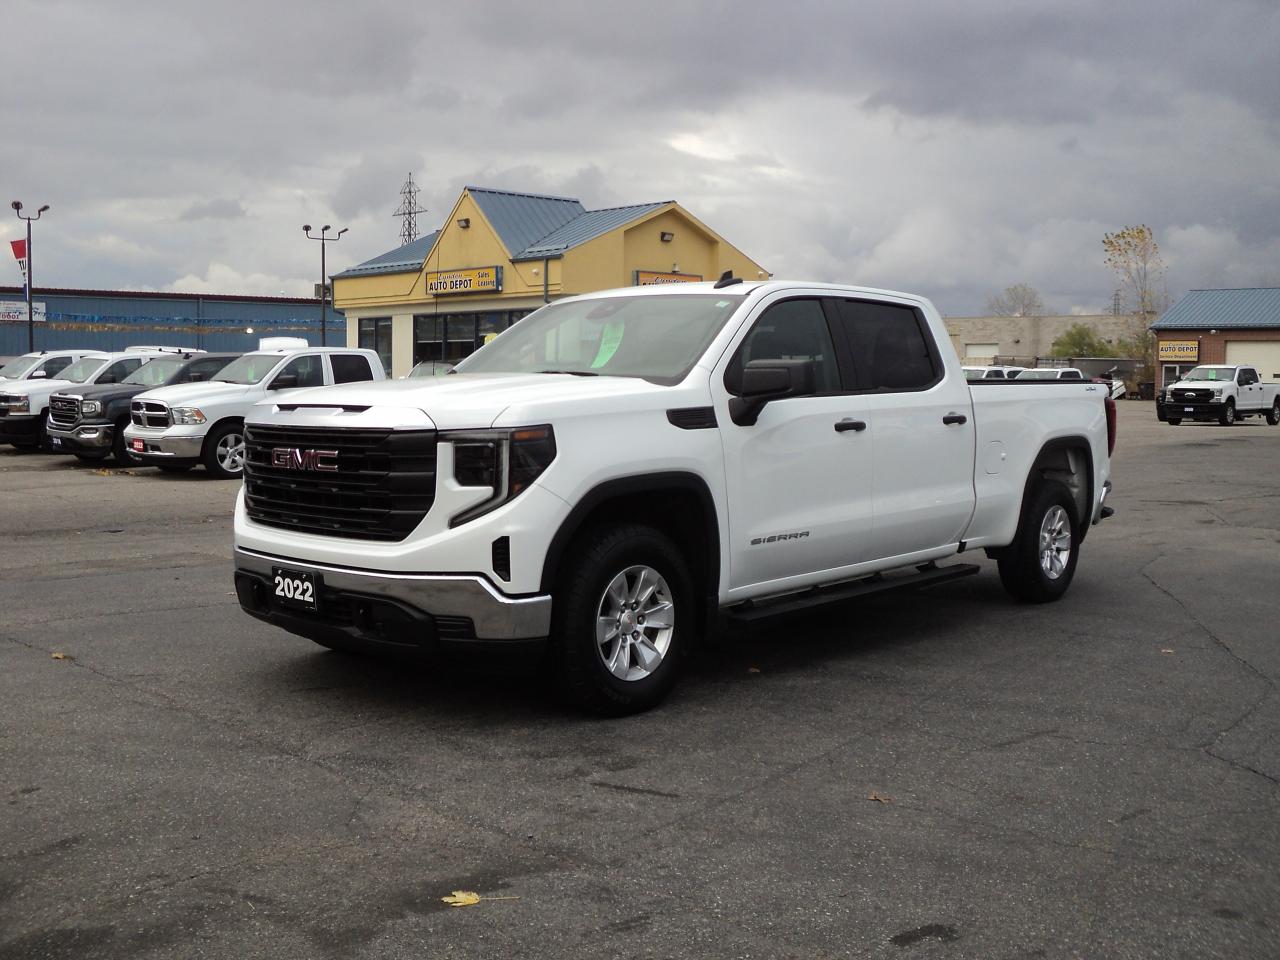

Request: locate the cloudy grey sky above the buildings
(0, 0), (1280, 315)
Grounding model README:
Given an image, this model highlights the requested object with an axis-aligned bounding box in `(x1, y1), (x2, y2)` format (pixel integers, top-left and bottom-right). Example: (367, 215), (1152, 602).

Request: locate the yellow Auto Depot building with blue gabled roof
(332, 187), (769, 376)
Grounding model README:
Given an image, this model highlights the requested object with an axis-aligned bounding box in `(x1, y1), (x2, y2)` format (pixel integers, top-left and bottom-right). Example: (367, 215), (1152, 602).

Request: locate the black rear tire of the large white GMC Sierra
(998, 480), (1080, 603)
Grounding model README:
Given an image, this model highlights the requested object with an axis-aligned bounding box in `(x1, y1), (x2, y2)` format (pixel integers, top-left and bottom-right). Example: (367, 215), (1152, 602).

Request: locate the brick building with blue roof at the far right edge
(1151, 287), (1280, 389)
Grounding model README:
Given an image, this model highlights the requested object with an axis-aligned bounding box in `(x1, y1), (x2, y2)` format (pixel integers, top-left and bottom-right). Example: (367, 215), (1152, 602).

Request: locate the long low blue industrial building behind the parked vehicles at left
(0, 287), (347, 356)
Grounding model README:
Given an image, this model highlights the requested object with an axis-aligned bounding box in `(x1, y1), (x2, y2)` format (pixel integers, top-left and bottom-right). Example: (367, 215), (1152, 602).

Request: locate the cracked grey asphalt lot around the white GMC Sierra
(0, 402), (1280, 960)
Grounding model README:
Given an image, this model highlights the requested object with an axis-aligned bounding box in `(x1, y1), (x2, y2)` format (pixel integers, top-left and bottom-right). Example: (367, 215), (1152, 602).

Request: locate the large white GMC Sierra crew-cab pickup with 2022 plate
(234, 275), (1115, 714)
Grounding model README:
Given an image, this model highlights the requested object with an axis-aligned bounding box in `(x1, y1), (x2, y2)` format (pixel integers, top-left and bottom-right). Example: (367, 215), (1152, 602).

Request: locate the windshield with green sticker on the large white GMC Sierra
(457, 293), (744, 384)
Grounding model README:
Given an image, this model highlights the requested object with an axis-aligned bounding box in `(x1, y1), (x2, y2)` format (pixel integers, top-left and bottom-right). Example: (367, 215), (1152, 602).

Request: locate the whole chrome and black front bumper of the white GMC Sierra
(236, 547), (552, 652)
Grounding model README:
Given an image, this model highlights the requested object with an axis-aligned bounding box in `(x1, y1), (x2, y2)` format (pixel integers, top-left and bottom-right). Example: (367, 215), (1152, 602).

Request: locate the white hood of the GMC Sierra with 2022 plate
(261, 374), (673, 430)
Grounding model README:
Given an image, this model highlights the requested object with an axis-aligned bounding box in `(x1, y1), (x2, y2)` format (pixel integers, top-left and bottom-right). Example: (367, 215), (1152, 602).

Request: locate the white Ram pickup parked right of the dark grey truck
(124, 347), (387, 479)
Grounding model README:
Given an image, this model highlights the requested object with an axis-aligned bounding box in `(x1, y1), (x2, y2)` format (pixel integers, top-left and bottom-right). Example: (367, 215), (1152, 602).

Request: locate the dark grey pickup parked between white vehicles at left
(46, 353), (241, 463)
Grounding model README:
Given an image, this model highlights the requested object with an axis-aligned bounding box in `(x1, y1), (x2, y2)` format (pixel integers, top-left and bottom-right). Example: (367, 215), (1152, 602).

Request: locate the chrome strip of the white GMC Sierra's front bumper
(236, 547), (552, 640)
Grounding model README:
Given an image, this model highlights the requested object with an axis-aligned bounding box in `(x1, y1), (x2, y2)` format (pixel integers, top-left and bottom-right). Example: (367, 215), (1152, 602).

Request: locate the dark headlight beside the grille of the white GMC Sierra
(440, 425), (556, 526)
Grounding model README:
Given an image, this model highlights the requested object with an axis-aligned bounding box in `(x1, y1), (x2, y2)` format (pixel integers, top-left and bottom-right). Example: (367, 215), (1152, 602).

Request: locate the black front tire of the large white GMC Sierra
(550, 524), (695, 717)
